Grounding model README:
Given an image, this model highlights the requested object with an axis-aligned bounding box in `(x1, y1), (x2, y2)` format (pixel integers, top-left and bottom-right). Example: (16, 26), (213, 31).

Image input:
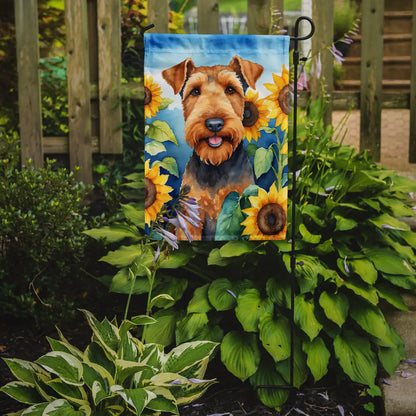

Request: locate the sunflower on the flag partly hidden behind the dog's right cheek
(243, 90), (269, 142)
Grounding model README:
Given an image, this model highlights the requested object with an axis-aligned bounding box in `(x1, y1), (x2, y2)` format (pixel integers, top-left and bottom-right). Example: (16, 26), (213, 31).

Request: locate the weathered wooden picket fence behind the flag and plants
(15, 0), (416, 183)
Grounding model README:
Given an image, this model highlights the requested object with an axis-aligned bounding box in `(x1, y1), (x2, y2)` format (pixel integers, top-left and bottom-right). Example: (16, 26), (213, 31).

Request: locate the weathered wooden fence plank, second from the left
(65, 0), (92, 184)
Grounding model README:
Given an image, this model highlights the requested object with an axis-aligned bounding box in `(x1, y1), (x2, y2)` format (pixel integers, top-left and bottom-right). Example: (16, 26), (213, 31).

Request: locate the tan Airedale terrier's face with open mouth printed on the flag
(162, 56), (263, 165)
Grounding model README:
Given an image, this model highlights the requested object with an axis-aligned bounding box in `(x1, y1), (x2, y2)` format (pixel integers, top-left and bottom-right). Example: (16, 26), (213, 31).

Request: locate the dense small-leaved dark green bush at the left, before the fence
(0, 133), (87, 320)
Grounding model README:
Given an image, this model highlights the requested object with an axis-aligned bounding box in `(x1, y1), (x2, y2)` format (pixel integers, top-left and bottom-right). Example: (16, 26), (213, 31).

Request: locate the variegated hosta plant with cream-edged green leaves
(1, 311), (217, 416)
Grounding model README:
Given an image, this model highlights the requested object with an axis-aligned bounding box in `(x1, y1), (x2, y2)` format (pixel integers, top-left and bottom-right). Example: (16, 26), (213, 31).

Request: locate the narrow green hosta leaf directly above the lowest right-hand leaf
(350, 301), (394, 347)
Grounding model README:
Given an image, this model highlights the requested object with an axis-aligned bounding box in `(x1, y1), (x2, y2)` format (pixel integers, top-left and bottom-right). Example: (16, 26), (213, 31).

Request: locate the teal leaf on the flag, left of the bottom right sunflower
(215, 192), (244, 241)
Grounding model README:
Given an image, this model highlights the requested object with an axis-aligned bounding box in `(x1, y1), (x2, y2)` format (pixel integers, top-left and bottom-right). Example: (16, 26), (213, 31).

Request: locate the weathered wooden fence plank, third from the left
(97, 0), (123, 154)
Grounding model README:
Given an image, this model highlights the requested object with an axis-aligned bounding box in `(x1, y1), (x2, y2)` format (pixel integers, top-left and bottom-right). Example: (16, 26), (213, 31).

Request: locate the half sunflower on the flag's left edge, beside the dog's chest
(144, 160), (172, 225)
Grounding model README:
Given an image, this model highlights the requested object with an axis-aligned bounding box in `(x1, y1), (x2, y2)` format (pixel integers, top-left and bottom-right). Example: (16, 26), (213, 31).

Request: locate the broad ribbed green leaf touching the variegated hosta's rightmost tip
(221, 331), (261, 381)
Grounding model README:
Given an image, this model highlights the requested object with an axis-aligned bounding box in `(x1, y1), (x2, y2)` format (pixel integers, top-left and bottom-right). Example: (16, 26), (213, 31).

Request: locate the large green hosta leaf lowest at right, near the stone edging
(334, 331), (377, 386)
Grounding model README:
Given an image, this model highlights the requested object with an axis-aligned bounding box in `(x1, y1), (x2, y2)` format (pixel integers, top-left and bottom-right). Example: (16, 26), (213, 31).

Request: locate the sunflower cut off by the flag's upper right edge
(264, 65), (290, 131)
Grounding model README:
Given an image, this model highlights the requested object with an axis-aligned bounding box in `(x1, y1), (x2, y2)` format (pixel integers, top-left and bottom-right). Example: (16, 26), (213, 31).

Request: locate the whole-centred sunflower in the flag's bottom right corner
(241, 183), (287, 240)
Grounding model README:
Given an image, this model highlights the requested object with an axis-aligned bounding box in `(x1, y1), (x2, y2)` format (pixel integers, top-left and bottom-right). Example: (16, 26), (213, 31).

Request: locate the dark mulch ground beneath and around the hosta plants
(0, 320), (382, 416)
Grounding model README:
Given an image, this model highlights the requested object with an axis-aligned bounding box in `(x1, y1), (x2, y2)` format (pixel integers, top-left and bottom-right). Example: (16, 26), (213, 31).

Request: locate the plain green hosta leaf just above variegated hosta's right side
(144, 308), (181, 346)
